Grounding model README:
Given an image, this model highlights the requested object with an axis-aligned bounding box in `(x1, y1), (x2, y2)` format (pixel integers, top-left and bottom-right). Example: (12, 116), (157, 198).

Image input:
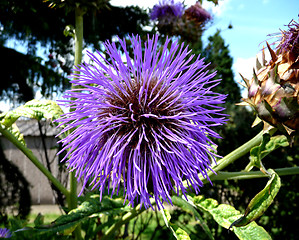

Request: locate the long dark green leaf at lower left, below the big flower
(35, 195), (129, 235)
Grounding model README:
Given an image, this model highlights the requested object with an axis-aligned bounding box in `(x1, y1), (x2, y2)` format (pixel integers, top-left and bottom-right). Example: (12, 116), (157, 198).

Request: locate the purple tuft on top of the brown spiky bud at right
(277, 20), (299, 56)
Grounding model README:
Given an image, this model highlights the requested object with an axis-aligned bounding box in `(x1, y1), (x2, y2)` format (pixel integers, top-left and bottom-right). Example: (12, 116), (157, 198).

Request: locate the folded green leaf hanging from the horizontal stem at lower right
(231, 169), (281, 227)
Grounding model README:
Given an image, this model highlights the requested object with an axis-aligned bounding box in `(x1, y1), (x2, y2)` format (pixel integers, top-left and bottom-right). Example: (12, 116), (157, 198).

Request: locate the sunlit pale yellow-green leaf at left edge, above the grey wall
(0, 99), (63, 128)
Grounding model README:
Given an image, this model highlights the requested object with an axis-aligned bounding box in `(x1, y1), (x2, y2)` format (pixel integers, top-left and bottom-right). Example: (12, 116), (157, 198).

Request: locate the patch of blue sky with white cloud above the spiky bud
(205, 0), (299, 80)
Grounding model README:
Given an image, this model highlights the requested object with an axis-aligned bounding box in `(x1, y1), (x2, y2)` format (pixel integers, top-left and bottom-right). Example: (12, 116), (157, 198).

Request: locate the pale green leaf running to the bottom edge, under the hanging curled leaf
(188, 196), (271, 240)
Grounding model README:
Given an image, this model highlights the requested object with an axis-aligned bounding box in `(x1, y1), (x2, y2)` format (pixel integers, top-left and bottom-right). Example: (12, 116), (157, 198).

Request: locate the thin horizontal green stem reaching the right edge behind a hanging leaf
(211, 167), (299, 181)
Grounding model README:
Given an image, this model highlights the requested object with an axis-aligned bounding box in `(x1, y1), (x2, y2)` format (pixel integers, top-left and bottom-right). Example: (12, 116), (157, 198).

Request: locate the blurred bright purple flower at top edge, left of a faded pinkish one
(150, 0), (184, 20)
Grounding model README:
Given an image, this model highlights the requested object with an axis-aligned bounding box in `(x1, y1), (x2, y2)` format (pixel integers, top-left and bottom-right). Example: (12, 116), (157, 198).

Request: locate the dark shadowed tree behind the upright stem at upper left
(0, 0), (149, 102)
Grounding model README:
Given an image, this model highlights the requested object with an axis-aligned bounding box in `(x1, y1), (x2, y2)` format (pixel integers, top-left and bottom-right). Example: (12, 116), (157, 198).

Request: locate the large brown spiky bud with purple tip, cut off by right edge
(242, 21), (299, 141)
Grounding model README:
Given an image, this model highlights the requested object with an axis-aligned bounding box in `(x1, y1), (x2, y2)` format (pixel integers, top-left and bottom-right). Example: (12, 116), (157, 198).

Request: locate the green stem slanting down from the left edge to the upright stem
(0, 127), (70, 199)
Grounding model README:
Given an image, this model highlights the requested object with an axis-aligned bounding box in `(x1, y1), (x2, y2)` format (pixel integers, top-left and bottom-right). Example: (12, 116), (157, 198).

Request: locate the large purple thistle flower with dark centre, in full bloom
(58, 35), (226, 208)
